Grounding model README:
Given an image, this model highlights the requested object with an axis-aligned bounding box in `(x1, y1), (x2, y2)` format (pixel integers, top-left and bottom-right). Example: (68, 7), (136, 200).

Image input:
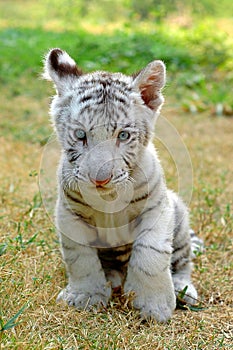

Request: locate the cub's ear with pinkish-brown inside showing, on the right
(134, 61), (166, 111)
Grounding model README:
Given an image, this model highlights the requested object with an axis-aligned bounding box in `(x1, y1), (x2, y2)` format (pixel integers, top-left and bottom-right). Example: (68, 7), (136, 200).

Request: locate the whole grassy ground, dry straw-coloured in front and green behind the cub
(0, 1), (233, 350)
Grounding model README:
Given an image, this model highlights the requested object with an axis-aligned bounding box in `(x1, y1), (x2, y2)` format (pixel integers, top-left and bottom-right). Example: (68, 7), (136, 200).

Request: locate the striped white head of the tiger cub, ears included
(45, 49), (165, 191)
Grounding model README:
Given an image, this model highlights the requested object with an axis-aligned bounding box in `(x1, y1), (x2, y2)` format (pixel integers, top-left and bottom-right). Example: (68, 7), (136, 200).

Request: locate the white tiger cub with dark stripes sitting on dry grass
(45, 49), (202, 322)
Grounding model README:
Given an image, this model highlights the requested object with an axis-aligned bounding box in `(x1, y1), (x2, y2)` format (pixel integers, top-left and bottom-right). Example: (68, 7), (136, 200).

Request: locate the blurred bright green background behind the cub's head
(0, 0), (233, 139)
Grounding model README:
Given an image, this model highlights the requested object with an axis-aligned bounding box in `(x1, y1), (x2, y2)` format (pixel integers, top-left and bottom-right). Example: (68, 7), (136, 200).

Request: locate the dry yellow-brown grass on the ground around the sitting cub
(0, 77), (233, 350)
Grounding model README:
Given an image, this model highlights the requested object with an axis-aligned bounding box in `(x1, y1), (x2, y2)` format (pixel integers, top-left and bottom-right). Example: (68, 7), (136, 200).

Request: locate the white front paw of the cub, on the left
(57, 285), (111, 310)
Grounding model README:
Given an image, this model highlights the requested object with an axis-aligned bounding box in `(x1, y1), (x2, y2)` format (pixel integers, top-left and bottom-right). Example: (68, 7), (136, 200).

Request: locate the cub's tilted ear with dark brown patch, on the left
(43, 49), (82, 94)
